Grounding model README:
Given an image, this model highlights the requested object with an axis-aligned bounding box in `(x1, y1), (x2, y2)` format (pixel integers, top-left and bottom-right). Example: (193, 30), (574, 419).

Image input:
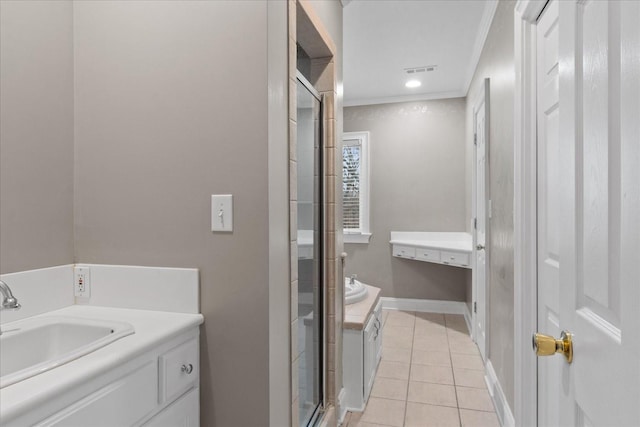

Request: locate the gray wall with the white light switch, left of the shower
(74, 1), (272, 426)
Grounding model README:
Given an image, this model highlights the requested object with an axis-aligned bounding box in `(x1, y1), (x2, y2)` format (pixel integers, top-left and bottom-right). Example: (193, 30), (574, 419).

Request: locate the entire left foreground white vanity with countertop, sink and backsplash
(0, 264), (204, 427)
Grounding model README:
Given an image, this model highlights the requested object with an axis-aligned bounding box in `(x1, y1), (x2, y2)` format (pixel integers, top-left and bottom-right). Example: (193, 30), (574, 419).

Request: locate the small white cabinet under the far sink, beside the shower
(342, 299), (382, 411)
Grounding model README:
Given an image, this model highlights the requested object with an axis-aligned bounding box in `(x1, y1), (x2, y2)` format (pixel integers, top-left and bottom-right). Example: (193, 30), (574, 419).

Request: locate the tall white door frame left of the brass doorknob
(514, 0), (547, 426)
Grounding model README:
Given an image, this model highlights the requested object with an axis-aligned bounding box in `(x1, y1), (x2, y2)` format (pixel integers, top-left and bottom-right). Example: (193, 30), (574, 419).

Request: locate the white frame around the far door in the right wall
(470, 78), (491, 363)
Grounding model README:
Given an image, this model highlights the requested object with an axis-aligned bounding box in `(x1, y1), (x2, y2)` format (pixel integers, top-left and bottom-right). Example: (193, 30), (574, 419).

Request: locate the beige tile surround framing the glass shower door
(289, 0), (344, 426)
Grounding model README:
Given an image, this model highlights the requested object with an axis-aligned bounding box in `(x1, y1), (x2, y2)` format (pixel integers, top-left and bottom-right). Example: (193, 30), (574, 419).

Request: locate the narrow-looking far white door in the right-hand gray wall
(473, 86), (488, 360)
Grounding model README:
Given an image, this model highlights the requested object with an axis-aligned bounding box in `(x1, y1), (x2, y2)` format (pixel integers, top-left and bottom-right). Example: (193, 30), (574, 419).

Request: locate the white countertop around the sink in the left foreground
(0, 305), (204, 423)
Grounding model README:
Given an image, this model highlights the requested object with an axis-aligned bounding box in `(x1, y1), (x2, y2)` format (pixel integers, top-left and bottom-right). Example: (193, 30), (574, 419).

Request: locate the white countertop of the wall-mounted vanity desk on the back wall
(389, 231), (473, 253)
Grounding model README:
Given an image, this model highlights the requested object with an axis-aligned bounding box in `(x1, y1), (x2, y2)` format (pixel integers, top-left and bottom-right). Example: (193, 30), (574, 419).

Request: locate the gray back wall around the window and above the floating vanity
(344, 98), (466, 301)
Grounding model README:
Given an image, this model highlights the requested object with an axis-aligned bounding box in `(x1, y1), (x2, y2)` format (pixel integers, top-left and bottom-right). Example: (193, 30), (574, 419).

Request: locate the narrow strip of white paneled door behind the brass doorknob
(536, 0), (564, 426)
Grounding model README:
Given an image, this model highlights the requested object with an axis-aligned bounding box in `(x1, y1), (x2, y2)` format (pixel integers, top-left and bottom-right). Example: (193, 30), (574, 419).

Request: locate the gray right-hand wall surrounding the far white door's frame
(467, 1), (515, 408)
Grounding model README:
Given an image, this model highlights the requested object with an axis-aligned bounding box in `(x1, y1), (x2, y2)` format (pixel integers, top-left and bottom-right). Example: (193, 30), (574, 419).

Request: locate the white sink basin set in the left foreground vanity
(0, 316), (134, 388)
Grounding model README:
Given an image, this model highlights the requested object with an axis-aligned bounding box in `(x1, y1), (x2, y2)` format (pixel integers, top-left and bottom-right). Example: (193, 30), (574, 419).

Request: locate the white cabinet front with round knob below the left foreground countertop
(30, 329), (200, 427)
